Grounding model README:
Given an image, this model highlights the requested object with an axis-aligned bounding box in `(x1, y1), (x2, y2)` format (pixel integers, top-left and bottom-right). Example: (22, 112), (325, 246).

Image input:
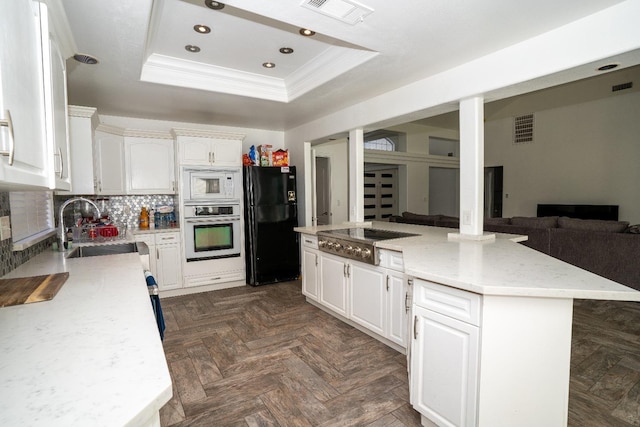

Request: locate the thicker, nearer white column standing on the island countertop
(460, 96), (484, 237)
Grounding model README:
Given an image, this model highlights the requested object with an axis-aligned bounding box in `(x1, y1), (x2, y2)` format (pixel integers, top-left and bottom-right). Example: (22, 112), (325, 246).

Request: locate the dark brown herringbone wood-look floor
(160, 282), (640, 427)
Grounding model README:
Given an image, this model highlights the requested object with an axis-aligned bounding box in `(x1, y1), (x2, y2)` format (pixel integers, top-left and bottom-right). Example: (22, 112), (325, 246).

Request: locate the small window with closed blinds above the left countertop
(9, 191), (55, 251)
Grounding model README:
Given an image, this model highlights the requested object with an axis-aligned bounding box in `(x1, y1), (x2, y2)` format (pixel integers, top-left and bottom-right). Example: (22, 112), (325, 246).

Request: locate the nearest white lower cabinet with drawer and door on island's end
(411, 280), (480, 426)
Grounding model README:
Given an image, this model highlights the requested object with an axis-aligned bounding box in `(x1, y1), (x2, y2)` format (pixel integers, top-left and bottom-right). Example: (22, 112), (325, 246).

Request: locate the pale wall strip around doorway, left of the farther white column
(312, 139), (349, 224)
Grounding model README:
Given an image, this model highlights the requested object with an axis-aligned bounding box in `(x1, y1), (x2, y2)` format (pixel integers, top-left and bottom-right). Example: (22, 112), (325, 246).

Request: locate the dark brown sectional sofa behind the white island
(389, 212), (640, 290)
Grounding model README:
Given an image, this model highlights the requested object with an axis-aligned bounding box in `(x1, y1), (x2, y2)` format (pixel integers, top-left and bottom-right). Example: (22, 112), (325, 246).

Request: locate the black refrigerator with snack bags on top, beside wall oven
(242, 166), (300, 286)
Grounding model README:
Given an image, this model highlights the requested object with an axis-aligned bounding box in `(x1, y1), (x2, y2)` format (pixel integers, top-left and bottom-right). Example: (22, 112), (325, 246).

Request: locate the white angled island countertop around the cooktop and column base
(296, 221), (640, 301)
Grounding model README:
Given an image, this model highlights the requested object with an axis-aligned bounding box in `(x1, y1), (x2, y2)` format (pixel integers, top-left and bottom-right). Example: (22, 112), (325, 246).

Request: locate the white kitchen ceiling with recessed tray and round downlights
(62, 0), (636, 130)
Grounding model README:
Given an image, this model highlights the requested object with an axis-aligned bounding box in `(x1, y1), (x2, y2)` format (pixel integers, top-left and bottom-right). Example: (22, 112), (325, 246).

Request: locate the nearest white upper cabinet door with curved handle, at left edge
(0, 0), (50, 189)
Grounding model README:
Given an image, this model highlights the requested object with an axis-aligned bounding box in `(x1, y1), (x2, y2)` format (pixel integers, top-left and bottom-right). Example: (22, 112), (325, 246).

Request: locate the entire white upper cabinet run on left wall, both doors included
(0, 0), (73, 190)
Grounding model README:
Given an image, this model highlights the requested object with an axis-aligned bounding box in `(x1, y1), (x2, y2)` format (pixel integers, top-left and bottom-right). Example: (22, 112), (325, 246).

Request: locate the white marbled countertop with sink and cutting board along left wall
(0, 247), (172, 427)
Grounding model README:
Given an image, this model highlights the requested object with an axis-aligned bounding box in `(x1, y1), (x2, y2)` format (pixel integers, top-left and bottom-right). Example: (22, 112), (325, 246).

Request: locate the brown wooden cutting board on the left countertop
(0, 273), (69, 307)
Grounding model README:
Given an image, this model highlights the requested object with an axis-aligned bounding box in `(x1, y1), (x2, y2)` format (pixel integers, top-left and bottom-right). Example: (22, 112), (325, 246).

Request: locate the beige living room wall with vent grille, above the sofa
(485, 92), (640, 224)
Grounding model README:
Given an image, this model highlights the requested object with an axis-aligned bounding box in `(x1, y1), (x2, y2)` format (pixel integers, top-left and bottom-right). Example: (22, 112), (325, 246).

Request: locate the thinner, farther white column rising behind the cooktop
(349, 129), (364, 222)
